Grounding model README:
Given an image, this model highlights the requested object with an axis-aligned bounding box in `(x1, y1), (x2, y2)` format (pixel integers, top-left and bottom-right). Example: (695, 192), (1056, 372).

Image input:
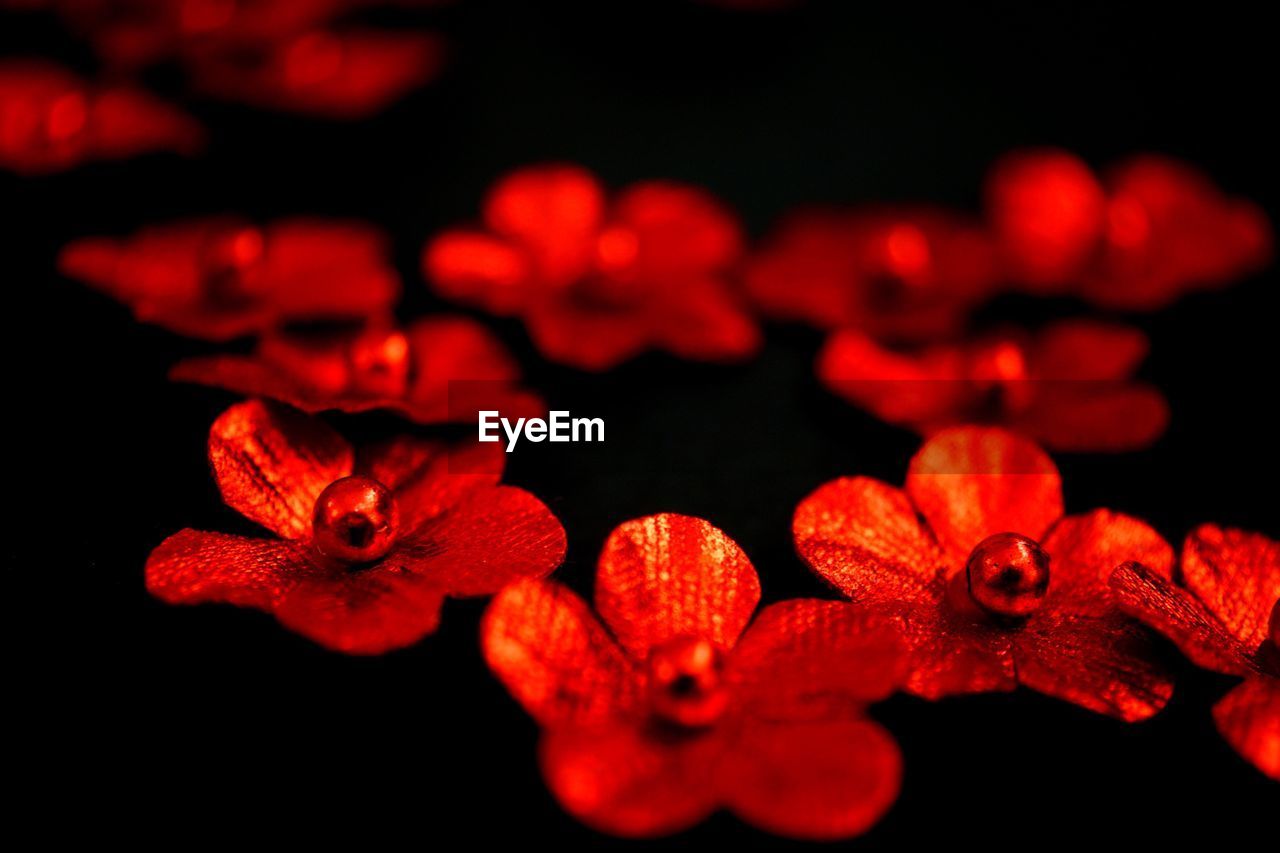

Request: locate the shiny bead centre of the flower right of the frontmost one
(965, 533), (1050, 619)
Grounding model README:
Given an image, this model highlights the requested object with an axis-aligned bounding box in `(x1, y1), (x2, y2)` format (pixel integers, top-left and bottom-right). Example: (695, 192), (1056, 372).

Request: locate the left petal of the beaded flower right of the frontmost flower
(791, 476), (945, 602)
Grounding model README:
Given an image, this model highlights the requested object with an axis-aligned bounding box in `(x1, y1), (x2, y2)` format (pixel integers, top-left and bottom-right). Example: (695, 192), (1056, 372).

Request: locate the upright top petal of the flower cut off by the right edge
(1181, 524), (1280, 649)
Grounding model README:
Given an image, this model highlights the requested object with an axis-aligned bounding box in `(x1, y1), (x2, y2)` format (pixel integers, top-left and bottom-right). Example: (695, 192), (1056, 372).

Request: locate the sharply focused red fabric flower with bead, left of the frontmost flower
(146, 400), (564, 654)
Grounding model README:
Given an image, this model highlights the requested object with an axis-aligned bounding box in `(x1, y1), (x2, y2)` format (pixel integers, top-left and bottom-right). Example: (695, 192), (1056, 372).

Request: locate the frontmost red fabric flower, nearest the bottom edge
(481, 515), (905, 838)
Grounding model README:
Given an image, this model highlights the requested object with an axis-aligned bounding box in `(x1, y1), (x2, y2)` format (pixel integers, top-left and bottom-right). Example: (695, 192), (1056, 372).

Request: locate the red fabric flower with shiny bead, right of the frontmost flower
(792, 427), (1174, 721)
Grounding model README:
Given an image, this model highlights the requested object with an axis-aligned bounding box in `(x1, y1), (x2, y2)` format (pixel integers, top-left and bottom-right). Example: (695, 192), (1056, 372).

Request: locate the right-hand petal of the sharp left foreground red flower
(399, 485), (564, 596)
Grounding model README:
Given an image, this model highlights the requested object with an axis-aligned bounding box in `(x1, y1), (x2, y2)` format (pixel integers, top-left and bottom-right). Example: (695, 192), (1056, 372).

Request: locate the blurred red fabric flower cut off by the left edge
(0, 60), (204, 174)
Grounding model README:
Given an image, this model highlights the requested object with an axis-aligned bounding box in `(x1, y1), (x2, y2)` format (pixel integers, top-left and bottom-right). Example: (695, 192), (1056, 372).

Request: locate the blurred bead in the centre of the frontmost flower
(649, 635), (728, 729)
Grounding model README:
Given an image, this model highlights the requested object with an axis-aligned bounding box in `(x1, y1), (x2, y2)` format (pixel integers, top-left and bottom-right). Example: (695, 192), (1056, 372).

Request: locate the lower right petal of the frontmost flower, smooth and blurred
(719, 720), (902, 839)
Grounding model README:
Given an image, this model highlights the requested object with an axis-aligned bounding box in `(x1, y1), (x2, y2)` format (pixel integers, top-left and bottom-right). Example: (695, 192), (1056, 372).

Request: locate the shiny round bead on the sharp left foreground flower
(311, 476), (399, 565)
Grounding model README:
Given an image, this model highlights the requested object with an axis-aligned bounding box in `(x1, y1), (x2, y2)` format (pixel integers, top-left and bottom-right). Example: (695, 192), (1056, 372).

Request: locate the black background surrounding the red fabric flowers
(0, 0), (1280, 850)
